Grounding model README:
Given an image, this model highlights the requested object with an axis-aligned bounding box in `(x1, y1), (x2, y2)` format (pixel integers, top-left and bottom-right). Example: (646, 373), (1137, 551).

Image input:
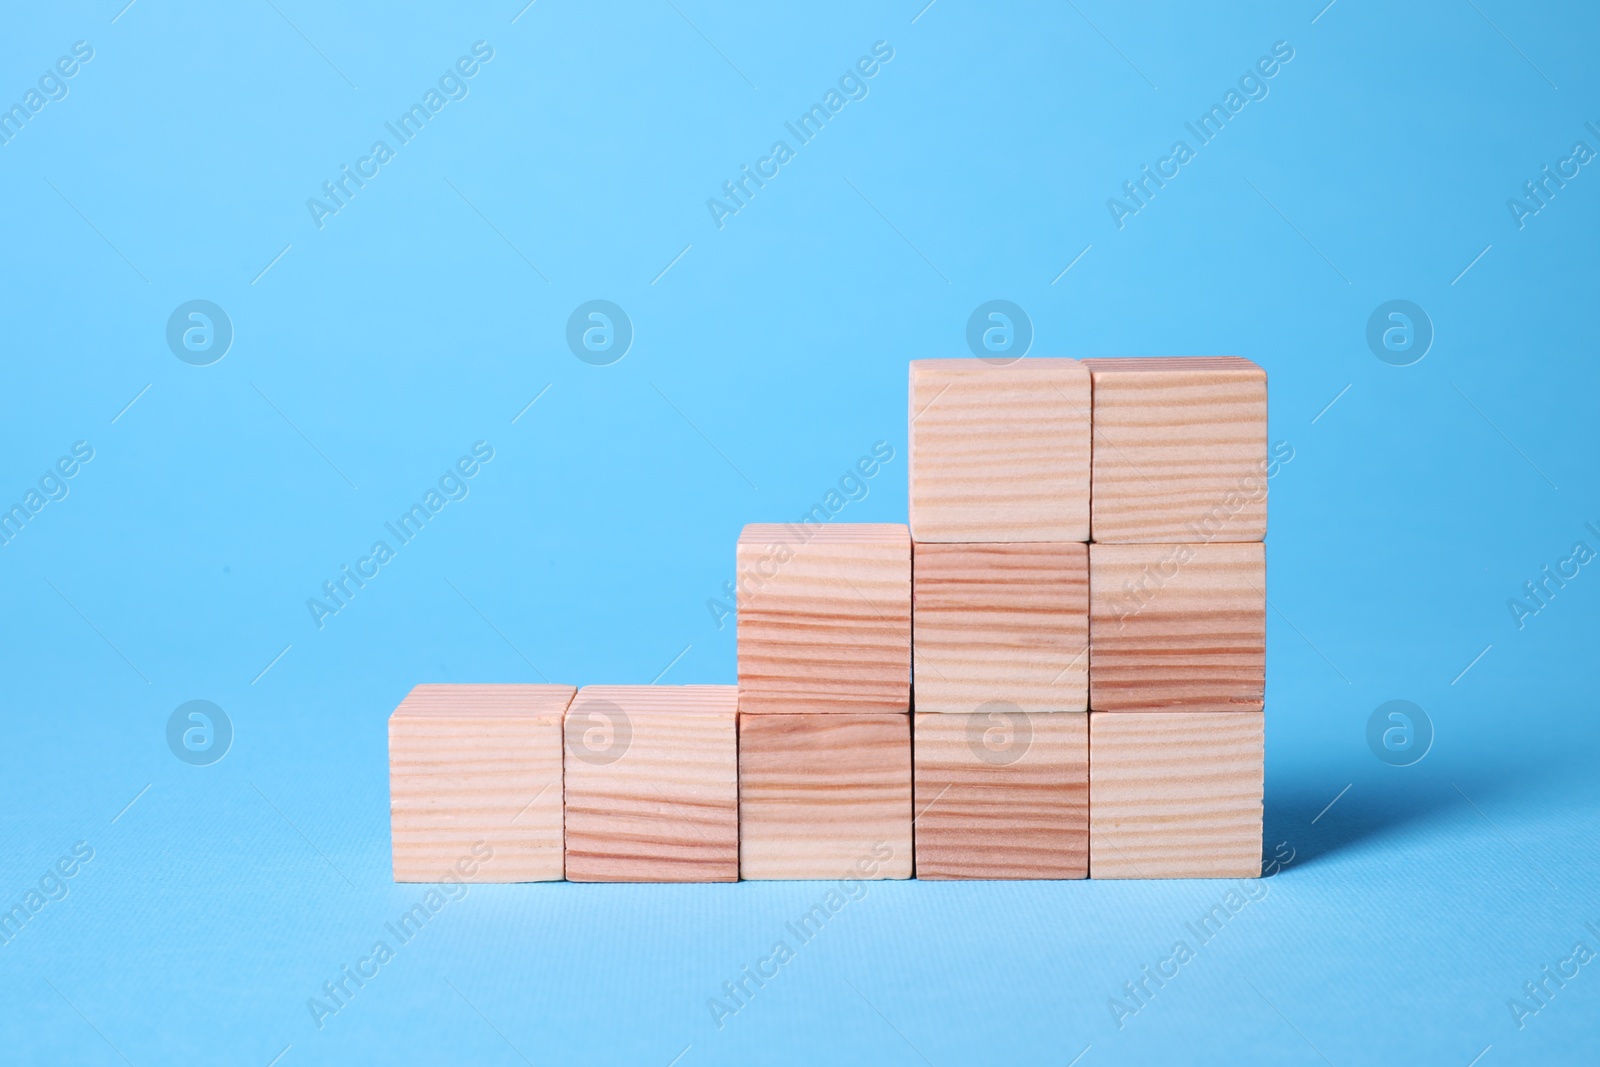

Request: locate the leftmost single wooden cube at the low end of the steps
(389, 685), (576, 881)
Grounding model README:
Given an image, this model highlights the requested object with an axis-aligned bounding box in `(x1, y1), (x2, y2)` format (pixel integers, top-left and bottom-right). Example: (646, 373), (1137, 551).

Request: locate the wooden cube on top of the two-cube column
(738, 523), (910, 715)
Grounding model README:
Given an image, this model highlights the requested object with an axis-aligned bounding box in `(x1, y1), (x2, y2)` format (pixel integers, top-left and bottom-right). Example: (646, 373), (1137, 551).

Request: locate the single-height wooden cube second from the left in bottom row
(566, 685), (739, 881)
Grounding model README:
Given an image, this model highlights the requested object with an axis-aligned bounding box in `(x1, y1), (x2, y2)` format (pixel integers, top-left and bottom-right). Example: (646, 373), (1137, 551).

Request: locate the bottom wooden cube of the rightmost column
(1090, 712), (1266, 878)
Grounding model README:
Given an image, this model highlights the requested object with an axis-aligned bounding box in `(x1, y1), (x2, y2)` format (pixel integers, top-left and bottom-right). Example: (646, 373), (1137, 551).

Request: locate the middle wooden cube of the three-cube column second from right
(912, 542), (1090, 713)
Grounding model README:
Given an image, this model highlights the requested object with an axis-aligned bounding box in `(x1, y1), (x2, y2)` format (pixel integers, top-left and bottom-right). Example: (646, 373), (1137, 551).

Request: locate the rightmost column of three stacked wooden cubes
(1085, 357), (1267, 878)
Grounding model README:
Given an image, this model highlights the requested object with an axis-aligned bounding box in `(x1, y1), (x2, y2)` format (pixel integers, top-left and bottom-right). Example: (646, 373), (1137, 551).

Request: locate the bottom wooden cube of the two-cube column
(739, 713), (912, 878)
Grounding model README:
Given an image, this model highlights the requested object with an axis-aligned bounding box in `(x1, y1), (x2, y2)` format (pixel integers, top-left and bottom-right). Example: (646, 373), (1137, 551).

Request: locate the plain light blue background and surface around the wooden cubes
(0, 0), (1600, 1067)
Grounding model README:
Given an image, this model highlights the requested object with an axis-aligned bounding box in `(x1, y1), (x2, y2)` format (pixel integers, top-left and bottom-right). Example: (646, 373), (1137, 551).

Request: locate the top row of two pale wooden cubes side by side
(909, 355), (1267, 544)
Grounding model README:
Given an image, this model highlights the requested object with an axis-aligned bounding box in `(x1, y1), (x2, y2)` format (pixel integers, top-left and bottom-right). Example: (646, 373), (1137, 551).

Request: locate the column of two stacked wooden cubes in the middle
(736, 523), (912, 878)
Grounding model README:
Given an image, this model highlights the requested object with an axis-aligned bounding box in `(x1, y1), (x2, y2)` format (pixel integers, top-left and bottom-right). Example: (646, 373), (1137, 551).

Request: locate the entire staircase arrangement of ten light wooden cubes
(389, 357), (1267, 881)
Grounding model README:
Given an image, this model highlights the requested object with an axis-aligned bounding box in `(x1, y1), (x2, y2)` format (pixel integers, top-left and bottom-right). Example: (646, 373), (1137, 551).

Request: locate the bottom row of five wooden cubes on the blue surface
(389, 685), (1264, 881)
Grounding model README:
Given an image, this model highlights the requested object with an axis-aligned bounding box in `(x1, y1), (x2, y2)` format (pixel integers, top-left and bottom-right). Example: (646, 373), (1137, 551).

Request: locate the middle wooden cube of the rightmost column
(1090, 541), (1267, 712)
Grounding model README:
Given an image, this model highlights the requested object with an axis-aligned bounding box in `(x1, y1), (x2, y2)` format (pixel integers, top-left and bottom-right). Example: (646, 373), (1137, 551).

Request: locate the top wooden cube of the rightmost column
(1083, 355), (1267, 544)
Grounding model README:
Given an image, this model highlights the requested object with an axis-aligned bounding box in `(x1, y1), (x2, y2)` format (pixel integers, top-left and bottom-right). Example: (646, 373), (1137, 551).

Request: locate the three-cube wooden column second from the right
(909, 358), (1091, 878)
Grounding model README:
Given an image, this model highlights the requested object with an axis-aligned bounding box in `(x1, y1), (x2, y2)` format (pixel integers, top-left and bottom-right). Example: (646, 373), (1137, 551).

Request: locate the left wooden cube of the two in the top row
(909, 358), (1090, 542)
